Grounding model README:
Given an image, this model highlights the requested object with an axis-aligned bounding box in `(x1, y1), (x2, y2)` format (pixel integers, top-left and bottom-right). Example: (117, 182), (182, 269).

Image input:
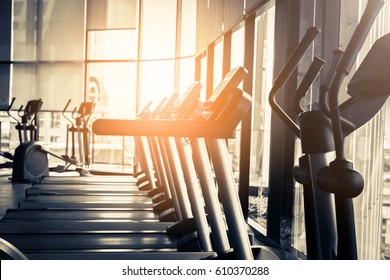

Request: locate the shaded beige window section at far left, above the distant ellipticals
(10, 0), (85, 110)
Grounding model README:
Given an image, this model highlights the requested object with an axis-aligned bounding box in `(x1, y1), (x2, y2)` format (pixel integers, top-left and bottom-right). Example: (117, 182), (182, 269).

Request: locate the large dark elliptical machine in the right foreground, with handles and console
(269, 1), (390, 259)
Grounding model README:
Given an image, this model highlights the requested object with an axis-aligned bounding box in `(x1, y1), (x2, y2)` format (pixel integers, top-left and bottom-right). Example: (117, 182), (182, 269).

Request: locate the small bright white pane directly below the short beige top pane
(88, 30), (138, 60)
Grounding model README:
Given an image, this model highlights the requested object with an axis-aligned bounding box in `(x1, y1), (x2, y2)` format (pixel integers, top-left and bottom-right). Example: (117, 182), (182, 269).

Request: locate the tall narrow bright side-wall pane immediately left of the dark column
(249, 7), (275, 232)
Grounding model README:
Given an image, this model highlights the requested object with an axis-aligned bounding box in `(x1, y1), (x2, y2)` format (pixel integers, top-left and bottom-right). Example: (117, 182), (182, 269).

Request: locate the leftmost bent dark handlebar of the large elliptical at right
(269, 27), (320, 137)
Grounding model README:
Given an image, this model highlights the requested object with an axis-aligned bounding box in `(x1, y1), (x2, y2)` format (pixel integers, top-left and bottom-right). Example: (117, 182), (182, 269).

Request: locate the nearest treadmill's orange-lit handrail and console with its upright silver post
(93, 66), (282, 259)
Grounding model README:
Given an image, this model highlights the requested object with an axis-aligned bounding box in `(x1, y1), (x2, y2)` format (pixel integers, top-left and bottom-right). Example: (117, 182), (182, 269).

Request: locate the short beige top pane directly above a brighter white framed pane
(87, 0), (138, 29)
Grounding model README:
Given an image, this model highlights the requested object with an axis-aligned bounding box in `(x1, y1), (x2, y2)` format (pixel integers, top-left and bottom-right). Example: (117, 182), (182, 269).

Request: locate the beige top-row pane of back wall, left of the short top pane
(38, 0), (85, 61)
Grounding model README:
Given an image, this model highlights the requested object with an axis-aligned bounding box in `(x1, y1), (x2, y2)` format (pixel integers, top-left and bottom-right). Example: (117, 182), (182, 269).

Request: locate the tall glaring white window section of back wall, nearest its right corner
(139, 0), (176, 107)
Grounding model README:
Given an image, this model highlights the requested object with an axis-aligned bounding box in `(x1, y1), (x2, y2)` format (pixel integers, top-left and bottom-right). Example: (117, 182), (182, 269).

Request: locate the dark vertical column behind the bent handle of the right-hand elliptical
(267, 0), (300, 244)
